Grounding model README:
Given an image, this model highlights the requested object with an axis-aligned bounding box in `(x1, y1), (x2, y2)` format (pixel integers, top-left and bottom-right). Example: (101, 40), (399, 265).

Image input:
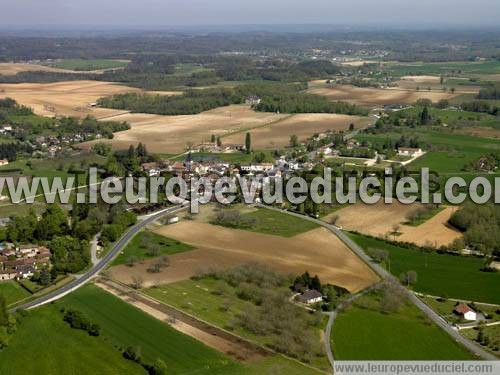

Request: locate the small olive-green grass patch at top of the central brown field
(242, 209), (318, 237)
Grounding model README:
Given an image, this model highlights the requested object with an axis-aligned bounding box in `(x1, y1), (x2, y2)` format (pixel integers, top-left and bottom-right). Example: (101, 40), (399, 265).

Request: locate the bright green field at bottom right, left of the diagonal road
(332, 295), (473, 360)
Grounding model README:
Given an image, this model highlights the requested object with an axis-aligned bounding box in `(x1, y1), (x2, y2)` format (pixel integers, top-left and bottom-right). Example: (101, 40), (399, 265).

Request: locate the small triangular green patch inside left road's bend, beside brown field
(113, 232), (194, 266)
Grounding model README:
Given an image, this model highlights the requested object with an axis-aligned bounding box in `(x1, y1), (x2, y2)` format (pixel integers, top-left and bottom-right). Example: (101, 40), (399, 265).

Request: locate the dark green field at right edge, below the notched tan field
(350, 234), (500, 304)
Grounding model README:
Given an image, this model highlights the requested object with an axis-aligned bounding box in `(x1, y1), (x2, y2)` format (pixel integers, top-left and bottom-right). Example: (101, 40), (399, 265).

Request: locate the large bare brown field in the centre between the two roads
(109, 221), (378, 292)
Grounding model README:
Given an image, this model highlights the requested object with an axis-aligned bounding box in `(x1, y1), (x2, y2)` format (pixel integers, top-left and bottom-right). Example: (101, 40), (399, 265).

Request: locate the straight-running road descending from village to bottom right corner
(256, 204), (498, 361)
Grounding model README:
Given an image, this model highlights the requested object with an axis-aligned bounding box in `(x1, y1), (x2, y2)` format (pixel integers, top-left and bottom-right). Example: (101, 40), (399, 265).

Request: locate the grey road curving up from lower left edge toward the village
(13, 205), (186, 311)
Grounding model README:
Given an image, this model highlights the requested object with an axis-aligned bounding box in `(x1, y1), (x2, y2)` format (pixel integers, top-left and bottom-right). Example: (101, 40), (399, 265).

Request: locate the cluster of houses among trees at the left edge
(0, 244), (51, 282)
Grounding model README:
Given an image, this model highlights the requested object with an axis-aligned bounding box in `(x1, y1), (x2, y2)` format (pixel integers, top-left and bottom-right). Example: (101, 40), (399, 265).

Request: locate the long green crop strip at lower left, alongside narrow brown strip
(57, 285), (241, 373)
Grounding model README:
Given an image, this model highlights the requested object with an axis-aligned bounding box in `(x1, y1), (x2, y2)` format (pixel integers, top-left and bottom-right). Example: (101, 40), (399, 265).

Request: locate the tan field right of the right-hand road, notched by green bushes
(325, 201), (462, 247)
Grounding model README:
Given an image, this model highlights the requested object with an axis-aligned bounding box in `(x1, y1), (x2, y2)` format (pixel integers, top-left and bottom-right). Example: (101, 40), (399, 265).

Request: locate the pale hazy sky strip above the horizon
(0, 0), (500, 27)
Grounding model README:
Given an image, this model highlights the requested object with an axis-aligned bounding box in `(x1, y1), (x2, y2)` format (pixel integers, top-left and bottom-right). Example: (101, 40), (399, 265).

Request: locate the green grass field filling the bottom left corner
(0, 305), (146, 375)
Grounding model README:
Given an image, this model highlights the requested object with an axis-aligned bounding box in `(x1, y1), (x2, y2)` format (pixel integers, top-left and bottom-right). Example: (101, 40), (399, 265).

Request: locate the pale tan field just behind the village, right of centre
(224, 113), (371, 150)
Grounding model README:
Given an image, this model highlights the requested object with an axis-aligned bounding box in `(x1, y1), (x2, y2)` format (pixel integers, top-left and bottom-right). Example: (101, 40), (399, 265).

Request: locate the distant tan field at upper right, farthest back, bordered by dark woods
(308, 81), (458, 106)
